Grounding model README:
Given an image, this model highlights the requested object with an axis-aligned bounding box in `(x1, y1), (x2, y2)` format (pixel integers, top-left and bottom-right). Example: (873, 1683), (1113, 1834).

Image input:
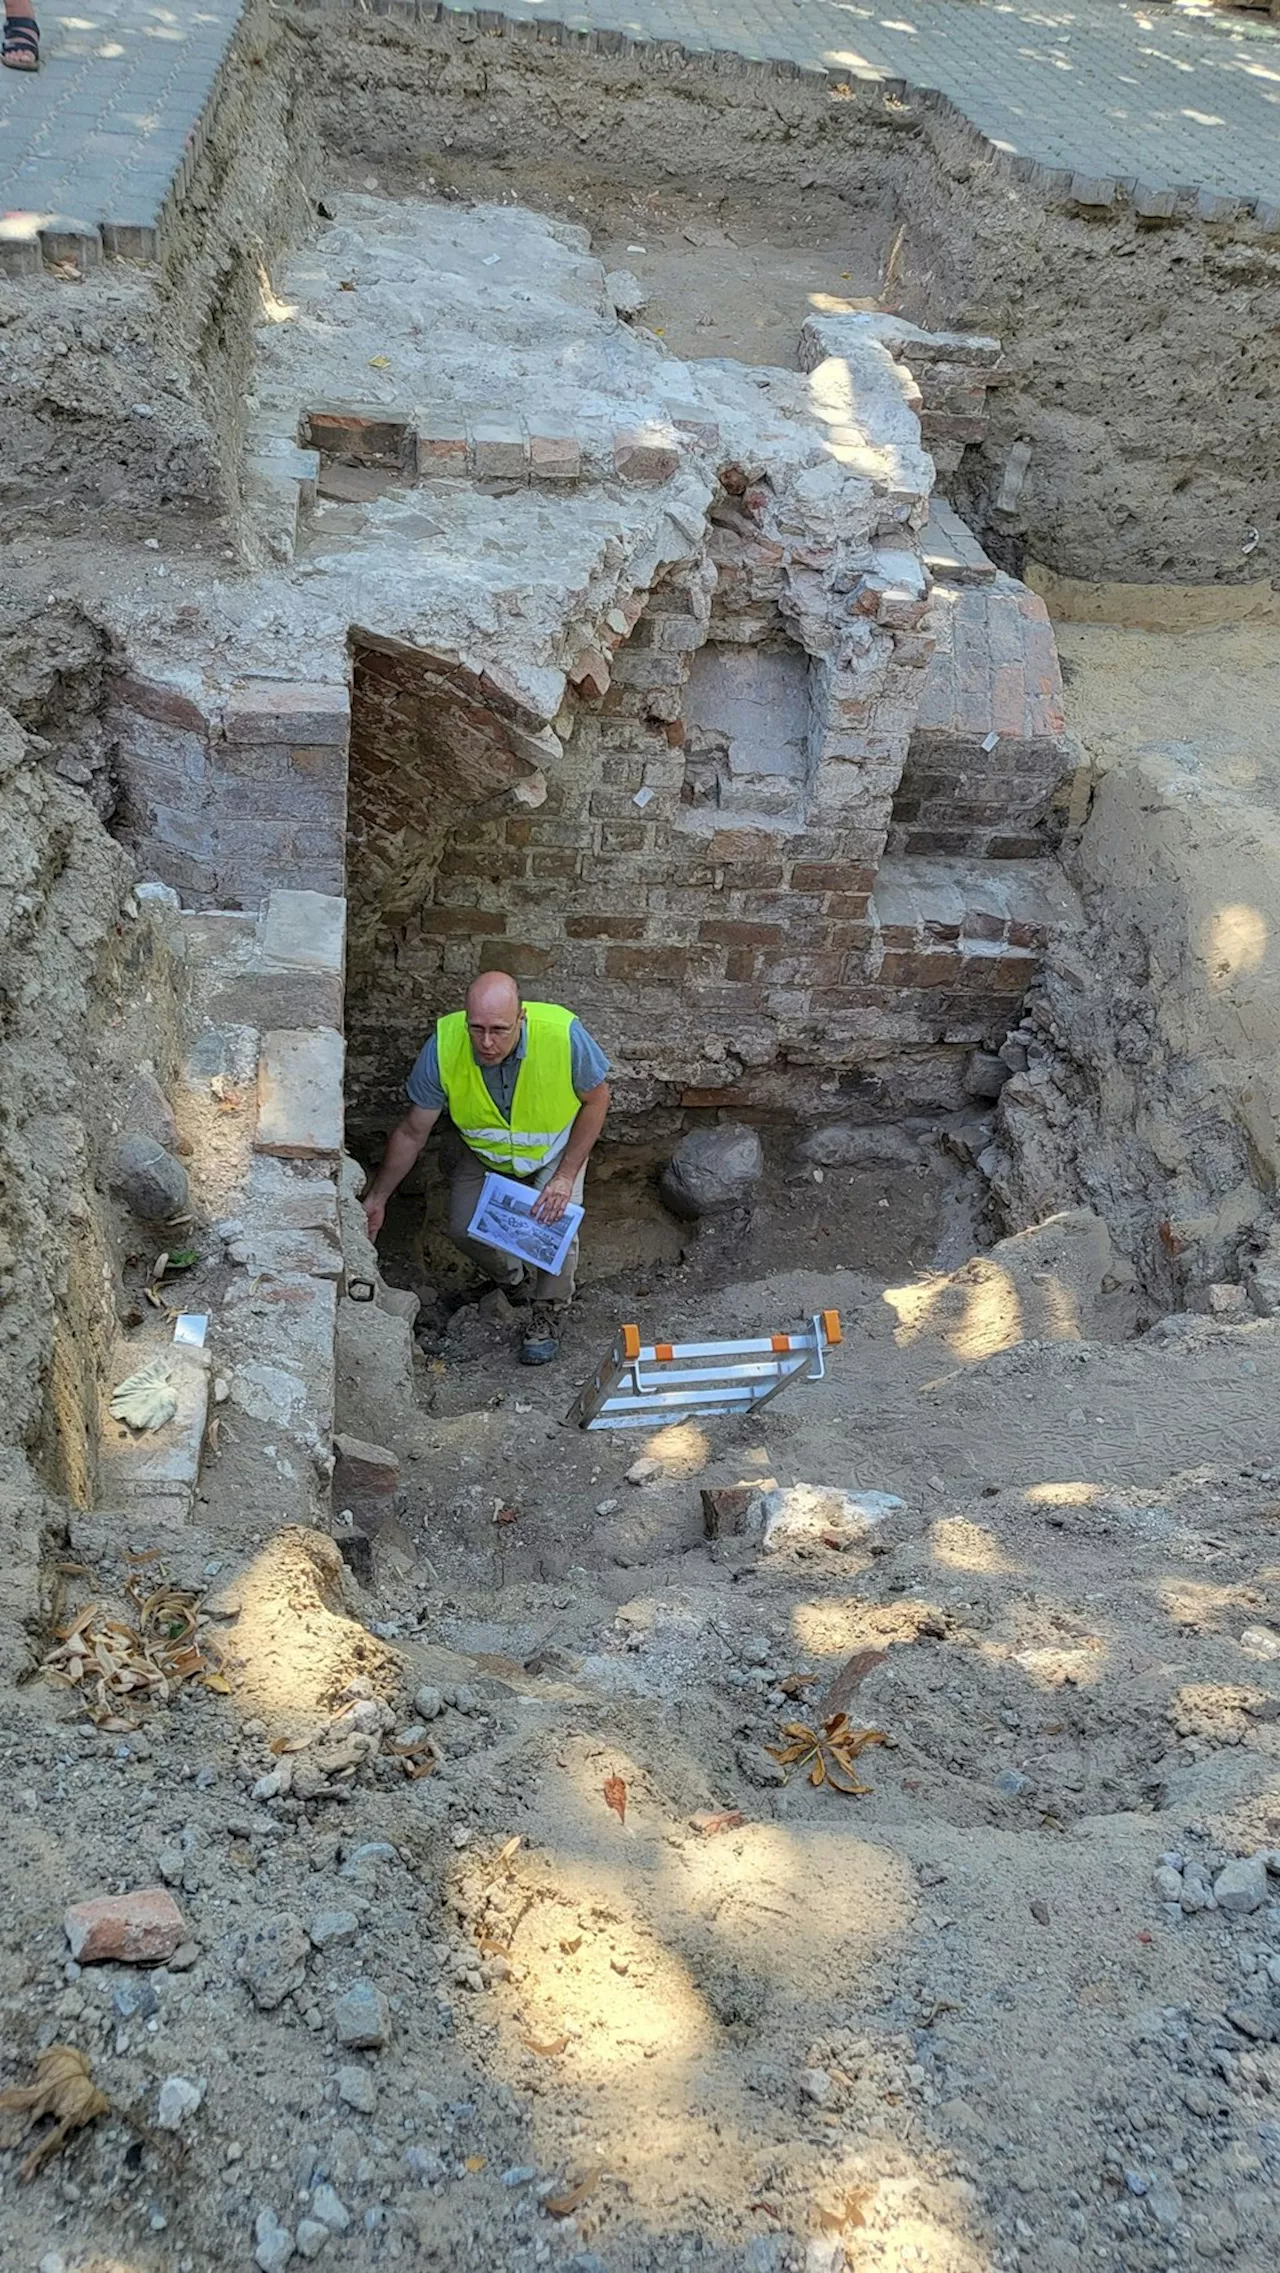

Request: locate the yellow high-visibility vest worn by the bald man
(437, 1002), (580, 1175)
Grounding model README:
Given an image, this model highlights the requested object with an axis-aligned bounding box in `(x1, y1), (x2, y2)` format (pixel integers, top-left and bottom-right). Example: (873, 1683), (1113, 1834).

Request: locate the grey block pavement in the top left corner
(0, 0), (241, 252)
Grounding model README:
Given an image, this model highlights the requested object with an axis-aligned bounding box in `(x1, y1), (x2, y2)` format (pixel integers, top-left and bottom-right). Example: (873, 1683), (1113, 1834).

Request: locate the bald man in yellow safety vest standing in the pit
(364, 971), (609, 1366)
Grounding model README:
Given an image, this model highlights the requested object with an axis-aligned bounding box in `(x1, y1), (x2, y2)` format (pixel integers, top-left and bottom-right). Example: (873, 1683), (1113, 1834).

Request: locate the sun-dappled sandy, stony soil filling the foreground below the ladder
(0, 1164), (1280, 2273)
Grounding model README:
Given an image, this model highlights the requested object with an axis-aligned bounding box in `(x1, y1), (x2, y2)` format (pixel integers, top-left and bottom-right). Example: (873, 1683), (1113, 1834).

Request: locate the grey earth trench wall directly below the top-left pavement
(0, 5), (314, 543)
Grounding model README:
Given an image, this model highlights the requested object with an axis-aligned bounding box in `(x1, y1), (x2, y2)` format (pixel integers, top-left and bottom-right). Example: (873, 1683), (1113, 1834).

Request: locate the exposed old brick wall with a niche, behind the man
(348, 516), (1064, 1134)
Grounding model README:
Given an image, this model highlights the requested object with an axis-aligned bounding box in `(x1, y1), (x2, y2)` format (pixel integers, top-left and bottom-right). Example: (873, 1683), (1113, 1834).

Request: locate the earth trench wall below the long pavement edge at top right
(296, 7), (1280, 584)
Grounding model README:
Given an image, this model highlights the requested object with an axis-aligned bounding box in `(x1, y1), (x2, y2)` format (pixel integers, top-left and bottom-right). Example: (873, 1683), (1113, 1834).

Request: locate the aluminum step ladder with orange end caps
(564, 1309), (843, 1427)
